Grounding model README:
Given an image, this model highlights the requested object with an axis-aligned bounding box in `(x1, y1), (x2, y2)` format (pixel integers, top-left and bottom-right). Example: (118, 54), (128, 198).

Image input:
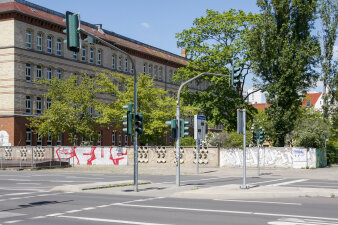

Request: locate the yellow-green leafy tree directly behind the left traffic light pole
(101, 74), (196, 144)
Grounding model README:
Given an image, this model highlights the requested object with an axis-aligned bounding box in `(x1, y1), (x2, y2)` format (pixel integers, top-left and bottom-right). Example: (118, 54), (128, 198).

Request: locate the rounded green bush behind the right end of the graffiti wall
(291, 107), (330, 148)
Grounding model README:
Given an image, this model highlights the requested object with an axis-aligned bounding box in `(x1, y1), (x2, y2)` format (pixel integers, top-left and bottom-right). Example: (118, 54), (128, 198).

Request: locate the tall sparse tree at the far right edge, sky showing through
(319, 0), (338, 119)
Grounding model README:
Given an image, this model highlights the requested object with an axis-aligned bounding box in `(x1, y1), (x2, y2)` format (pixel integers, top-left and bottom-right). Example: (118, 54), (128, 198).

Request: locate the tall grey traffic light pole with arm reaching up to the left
(78, 27), (138, 192)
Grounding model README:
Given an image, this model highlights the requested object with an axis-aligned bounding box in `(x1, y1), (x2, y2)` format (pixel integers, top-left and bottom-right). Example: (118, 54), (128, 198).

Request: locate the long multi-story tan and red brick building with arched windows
(0, 0), (210, 145)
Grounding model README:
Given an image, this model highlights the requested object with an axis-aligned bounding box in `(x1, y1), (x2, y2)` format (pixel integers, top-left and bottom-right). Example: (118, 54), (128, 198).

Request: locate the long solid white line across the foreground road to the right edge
(115, 203), (338, 221)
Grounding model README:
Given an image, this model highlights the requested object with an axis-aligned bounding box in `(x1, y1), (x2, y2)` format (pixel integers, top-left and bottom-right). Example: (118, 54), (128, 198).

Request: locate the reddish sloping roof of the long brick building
(0, 0), (188, 65)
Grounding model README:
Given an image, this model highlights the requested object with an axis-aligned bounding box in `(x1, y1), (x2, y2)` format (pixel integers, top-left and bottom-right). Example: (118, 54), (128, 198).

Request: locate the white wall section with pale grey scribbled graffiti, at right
(220, 148), (316, 168)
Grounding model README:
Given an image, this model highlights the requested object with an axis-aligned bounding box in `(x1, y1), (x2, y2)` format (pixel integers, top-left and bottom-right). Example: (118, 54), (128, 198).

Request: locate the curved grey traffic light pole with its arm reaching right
(176, 72), (230, 186)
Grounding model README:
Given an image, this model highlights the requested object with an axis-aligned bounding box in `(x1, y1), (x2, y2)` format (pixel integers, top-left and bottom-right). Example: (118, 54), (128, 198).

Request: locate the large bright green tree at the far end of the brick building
(174, 9), (257, 130)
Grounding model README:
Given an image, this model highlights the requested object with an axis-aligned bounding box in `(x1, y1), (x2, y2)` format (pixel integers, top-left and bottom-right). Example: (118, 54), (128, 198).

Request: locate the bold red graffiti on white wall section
(55, 146), (127, 165)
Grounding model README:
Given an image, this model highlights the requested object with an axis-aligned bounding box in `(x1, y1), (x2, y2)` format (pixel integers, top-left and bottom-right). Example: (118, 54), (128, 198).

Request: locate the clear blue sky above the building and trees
(28, 0), (332, 91)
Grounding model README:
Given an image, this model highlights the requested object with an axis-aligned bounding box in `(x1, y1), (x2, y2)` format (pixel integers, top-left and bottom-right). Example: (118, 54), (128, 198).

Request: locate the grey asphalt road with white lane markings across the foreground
(0, 171), (338, 225)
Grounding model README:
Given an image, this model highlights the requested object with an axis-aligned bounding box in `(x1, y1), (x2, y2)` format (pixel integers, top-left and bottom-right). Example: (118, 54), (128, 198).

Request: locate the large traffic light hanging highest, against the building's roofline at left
(63, 11), (80, 52)
